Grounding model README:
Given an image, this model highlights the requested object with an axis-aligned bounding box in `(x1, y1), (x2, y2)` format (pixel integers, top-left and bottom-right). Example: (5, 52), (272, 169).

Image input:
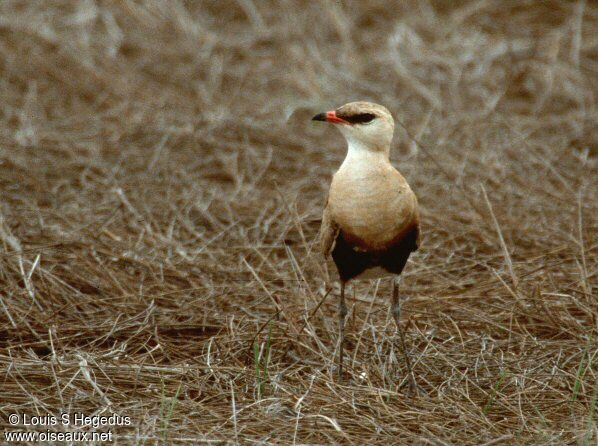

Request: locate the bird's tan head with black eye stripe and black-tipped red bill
(312, 102), (395, 151)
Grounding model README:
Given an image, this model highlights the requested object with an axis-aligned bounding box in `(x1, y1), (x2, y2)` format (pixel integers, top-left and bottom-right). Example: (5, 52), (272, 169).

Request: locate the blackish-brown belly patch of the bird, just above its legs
(332, 227), (418, 282)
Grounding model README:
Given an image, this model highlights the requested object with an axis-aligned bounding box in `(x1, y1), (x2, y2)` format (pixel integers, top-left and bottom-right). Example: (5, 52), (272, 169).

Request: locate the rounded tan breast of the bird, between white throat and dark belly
(329, 163), (417, 249)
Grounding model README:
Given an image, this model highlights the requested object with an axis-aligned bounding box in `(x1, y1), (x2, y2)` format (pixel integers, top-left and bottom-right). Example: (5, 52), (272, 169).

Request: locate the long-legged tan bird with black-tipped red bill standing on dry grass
(312, 101), (421, 393)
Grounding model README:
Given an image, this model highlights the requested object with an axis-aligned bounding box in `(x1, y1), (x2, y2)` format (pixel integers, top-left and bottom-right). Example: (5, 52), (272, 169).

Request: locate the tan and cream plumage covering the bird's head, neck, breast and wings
(320, 102), (419, 278)
